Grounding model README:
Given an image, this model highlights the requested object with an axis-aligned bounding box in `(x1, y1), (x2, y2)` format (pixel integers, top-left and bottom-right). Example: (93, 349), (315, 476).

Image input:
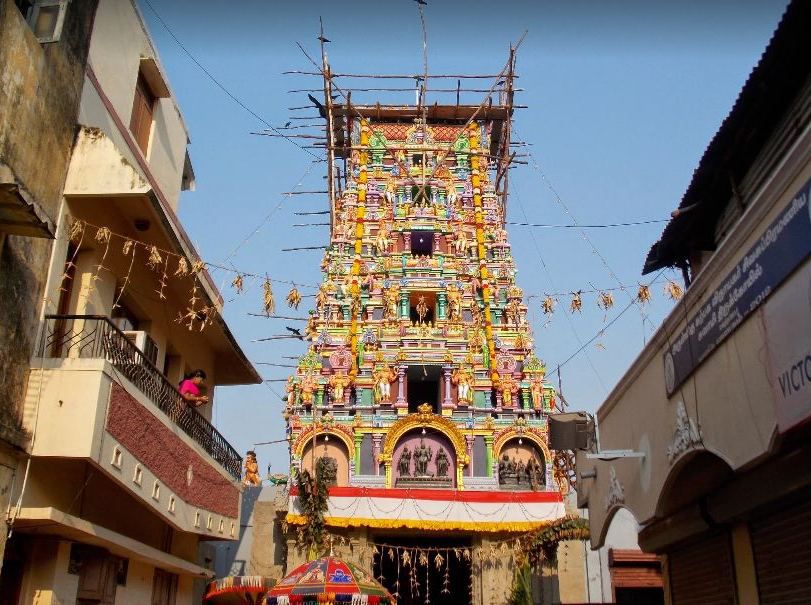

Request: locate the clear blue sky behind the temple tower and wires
(141, 0), (786, 472)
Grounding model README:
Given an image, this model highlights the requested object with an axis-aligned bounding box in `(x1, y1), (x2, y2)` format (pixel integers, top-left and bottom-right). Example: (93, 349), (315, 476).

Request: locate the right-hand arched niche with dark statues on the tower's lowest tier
(496, 435), (551, 490)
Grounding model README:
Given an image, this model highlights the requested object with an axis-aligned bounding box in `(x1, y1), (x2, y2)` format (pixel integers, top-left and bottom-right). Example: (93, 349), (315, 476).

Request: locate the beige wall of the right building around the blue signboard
(578, 104), (811, 544)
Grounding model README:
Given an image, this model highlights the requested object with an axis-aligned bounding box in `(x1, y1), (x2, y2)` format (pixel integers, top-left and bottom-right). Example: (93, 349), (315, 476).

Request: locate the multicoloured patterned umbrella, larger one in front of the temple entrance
(265, 556), (396, 605)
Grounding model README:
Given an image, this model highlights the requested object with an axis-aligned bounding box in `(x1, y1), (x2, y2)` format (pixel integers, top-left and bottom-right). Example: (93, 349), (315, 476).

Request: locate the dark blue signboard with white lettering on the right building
(664, 179), (811, 397)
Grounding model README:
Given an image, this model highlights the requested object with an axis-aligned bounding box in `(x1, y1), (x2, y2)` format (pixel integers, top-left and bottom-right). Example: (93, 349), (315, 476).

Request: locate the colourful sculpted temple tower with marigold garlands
(285, 54), (564, 604)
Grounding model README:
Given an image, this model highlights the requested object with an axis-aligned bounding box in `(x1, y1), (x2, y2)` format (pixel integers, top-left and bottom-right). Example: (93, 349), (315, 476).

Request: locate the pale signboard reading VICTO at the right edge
(763, 262), (811, 433)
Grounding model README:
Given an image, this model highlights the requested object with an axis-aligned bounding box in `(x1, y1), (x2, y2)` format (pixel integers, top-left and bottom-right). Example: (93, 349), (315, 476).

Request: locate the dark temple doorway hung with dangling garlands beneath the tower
(372, 534), (473, 605)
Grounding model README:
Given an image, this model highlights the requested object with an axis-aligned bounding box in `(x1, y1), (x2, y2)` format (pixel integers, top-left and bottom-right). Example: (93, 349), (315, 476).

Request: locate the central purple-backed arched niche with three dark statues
(391, 428), (457, 489)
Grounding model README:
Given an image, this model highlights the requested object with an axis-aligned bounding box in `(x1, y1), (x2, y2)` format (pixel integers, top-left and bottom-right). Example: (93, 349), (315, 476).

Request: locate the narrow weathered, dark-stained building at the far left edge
(0, 0), (96, 572)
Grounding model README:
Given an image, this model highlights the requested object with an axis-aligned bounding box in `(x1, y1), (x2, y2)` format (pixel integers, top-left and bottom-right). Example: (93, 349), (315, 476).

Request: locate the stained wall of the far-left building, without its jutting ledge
(0, 0), (96, 443)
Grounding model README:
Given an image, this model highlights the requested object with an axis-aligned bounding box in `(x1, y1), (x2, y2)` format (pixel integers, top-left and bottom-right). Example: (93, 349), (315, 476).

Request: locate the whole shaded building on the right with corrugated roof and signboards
(577, 2), (811, 605)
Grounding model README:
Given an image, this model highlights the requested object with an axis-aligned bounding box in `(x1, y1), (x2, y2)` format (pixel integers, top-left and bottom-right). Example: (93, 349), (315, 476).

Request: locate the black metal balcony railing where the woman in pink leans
(40, 315), (242, 479)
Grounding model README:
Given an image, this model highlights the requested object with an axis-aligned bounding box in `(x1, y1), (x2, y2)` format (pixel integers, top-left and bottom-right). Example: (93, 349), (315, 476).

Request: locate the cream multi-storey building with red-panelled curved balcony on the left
(2, 0), (259, 604)
